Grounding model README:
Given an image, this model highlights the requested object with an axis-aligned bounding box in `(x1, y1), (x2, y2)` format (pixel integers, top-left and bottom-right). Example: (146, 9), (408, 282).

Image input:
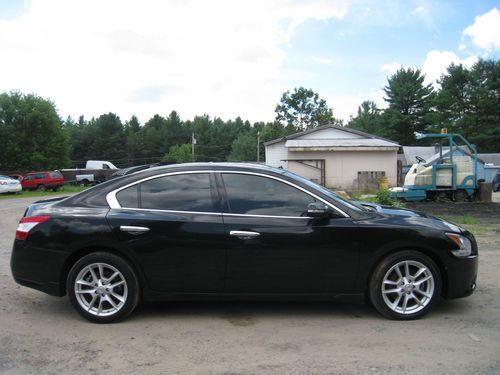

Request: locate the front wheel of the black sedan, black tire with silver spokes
(368, 250), (442, 320)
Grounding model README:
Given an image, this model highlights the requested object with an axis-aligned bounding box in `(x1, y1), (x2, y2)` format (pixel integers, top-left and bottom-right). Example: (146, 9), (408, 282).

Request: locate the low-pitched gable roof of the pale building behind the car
(264, 124), (399, 147)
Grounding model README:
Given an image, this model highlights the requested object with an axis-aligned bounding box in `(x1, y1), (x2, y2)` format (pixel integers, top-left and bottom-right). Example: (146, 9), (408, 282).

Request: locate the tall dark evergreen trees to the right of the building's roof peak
(347, 60), (500, 152)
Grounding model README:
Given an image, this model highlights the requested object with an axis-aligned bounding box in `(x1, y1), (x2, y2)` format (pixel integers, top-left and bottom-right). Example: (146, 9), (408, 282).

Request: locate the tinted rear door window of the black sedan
(140, 173), (217, 212)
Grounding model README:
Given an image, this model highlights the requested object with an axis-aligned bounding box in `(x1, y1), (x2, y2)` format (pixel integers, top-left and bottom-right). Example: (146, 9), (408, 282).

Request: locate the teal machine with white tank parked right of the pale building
(389, 134), (477, 201)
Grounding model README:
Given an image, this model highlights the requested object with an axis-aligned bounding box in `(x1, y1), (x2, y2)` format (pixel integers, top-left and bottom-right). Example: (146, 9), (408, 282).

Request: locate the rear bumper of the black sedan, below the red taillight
(10, 240), (65, 296)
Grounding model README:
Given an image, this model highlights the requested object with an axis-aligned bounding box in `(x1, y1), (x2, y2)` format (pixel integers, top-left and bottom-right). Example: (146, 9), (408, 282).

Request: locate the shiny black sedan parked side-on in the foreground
(11, 163), (478, 323)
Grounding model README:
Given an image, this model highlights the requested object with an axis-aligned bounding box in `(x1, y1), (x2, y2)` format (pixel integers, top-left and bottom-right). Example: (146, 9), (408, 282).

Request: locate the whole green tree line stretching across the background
(0, 60), (500, 171)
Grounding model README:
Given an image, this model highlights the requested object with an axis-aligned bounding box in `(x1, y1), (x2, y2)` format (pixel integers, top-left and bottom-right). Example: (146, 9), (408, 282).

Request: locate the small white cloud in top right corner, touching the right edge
(464, 8), (500, 50)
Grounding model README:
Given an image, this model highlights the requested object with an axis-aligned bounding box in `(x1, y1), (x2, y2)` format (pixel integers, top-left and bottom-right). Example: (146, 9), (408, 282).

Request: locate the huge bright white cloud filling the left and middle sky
(0, 0), (346, 121)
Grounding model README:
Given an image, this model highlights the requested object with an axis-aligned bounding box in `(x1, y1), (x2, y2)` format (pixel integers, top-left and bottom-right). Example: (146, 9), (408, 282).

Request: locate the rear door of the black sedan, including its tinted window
(107, 171), (226, 293)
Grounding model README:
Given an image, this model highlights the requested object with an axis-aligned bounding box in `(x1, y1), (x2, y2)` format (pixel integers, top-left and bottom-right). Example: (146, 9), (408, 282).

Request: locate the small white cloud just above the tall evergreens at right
(422, 50), (479, 86)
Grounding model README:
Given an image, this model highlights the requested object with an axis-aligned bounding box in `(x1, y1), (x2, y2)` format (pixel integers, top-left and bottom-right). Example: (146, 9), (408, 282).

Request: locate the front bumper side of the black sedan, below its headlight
(443, 255), (479, 299)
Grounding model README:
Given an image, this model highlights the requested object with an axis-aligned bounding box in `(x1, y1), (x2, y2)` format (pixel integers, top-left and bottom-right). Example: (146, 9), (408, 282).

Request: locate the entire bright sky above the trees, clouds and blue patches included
(0, 0), (500, 123)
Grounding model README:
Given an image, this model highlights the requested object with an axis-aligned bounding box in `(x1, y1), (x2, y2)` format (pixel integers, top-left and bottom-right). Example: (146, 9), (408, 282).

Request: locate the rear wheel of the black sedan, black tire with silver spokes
(66, 252), (140, 323)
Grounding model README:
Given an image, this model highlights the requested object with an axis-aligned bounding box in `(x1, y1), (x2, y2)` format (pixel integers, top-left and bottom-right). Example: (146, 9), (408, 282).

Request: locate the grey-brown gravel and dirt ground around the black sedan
(0, 199), (500, 374)
